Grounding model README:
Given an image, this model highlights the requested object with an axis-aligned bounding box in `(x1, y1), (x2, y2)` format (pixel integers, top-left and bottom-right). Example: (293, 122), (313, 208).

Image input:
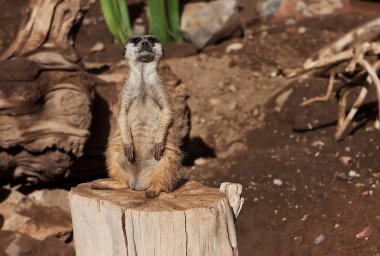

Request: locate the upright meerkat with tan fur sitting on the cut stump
(94, 35), (182, 198)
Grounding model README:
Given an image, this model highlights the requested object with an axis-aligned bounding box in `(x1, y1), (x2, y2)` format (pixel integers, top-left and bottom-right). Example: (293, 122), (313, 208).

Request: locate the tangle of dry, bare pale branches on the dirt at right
(284, 18), (380, 140)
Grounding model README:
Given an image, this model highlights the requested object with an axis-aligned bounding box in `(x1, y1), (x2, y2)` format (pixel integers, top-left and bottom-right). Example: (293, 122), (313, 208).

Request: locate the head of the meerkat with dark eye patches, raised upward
(124, 35), (164, 63)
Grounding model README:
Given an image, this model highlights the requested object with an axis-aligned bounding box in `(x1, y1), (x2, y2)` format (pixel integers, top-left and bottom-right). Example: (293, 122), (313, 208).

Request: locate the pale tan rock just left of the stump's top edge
(28, 189), (70, 213)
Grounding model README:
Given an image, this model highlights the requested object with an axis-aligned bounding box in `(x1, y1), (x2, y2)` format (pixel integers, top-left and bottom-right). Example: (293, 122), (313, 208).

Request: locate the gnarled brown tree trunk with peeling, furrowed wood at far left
(0, 0), (94, 182)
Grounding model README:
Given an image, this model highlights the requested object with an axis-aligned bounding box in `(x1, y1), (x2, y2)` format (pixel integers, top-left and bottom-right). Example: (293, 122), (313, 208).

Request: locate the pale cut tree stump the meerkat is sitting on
(70, 180), (238, 256)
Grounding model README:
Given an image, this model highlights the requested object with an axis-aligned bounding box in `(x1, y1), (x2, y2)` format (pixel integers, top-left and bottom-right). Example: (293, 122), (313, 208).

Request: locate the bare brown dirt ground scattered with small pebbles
(0, 1), (380, 256)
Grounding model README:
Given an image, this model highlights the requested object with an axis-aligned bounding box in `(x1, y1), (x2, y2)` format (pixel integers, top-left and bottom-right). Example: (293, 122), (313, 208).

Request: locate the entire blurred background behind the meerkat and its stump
(0, 0), (380, 256)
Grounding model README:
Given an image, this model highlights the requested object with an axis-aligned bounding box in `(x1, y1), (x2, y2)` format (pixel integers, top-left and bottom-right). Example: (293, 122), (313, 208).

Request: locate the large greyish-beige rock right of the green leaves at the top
(181, 0), (240, 49)
